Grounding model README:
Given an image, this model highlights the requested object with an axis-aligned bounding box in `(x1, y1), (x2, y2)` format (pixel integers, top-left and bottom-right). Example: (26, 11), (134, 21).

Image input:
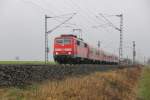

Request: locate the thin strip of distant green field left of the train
(0, 61), (56, 64)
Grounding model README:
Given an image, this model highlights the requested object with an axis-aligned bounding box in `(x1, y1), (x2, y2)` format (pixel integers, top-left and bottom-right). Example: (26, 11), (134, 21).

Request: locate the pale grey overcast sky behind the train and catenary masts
(0, 0), (150, 60)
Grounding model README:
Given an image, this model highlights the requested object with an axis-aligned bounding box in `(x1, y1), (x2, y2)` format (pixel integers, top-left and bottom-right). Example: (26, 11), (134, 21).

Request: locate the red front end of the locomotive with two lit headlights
(54, 35), (76, 63)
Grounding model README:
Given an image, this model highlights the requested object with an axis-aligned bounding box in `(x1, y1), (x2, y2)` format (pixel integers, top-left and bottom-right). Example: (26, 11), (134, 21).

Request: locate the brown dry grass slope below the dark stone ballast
(0, 68), (141, 100)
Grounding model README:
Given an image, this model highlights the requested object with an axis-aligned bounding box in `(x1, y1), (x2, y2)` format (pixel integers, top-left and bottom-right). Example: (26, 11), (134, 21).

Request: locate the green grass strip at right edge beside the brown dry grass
(139, 67), (150, 100)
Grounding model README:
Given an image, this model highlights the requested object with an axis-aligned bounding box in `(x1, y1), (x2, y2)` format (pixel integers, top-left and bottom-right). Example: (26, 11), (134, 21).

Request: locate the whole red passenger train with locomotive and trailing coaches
(53, 35), (118, 64)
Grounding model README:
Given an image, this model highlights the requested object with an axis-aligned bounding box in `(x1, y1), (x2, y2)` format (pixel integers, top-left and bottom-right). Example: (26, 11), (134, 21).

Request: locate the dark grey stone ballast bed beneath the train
(0, 64), (134, 86)
